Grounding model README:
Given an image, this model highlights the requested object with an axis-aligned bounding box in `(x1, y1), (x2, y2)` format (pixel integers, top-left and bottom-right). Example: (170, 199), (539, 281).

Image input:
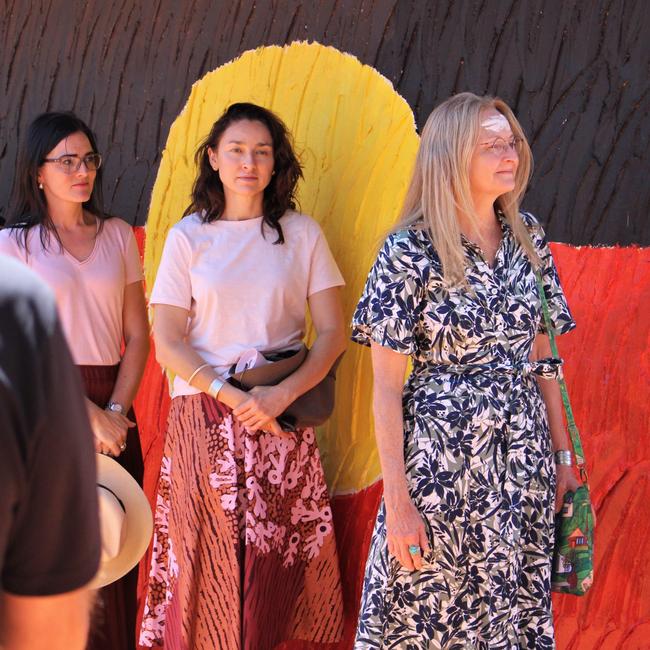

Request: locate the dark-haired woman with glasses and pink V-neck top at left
(0, 113), (149, 650)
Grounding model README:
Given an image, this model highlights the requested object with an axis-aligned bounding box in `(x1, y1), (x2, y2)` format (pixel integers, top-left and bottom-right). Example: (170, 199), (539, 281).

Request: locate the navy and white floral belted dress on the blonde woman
(352, 213), (575, 650)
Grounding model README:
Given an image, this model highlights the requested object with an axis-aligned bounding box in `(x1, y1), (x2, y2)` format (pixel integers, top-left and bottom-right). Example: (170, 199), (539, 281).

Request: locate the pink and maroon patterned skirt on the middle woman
(140, 393), (343, 650)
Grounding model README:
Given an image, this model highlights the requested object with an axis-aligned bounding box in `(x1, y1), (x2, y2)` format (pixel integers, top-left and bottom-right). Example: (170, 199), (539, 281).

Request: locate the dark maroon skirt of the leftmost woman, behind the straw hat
(77, 365), (144, 650)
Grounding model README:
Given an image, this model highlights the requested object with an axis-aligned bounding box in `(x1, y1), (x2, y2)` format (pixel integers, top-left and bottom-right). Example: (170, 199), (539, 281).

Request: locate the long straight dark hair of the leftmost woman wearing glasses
(4, 112), (107, 248)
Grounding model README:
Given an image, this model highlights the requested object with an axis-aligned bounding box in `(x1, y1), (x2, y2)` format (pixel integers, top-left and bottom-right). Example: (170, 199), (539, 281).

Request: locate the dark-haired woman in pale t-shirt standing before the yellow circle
(140, 103), (346, 650)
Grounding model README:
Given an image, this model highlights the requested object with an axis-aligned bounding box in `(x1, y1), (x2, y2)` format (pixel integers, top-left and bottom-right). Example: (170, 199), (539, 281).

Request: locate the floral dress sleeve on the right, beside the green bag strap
(522, 213), (576, 334)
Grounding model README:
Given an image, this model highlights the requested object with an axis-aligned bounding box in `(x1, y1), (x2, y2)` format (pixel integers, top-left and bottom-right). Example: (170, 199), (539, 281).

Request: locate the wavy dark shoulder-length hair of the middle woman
(183, 102), (302, 244)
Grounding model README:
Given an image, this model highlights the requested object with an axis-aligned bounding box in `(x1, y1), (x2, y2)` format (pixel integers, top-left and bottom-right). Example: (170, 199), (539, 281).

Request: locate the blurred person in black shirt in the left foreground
(0, 256), (101, 650)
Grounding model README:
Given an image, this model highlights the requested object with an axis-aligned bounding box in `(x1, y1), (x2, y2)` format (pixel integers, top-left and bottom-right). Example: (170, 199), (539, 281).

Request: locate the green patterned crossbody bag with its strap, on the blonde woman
(535, 273), (594, 596)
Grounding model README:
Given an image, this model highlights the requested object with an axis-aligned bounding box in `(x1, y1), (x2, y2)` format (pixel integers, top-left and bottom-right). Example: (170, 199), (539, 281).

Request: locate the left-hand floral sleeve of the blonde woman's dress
(352, 230), (430, 355)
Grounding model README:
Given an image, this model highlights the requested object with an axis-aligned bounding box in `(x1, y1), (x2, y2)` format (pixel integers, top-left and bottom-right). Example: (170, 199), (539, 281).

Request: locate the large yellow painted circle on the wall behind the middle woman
(145, 43), (418, 493)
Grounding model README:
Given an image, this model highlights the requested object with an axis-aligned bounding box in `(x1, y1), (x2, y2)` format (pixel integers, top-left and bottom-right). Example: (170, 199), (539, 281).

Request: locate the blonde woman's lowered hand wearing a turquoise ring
(385, 494), (430, 571)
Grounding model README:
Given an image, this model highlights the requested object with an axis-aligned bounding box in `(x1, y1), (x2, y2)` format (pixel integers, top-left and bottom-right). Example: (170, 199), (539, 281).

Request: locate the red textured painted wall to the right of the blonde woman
(552, 245), (650, 650)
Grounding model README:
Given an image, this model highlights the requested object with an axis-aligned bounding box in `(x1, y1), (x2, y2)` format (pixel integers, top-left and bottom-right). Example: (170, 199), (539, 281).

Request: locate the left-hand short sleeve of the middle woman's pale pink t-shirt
(149, 228), (192, 311)
